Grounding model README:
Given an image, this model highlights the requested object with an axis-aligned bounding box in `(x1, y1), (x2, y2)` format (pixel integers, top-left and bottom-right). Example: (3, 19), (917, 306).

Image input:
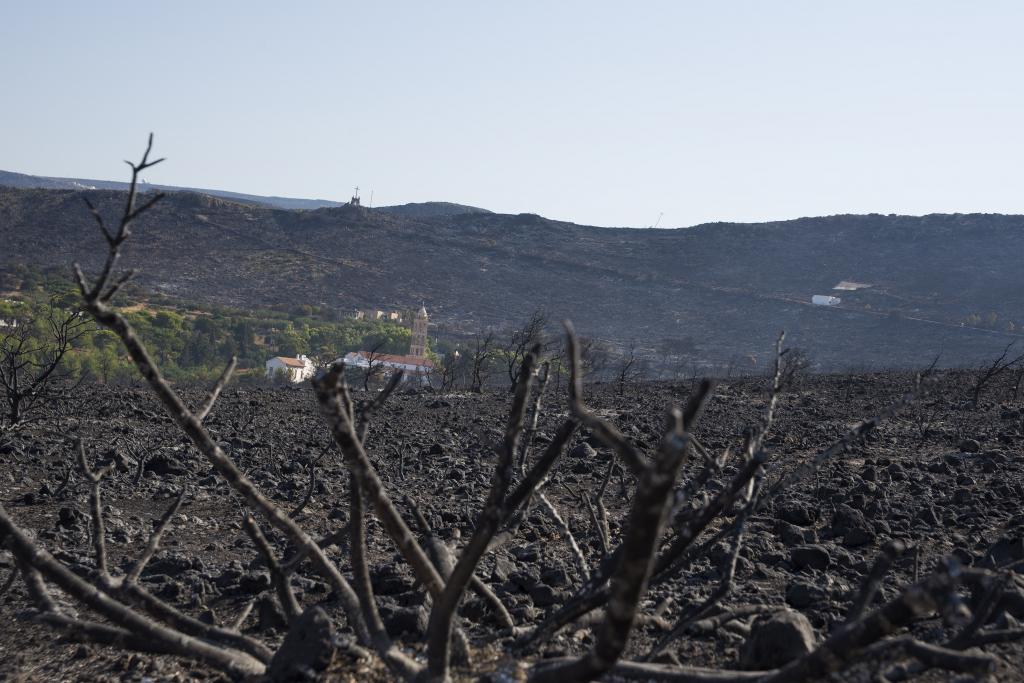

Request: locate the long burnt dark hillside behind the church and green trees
(0, 188), (1024, 371)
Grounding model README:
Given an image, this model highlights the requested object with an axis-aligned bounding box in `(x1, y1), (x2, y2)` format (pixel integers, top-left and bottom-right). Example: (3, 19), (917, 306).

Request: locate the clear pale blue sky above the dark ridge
(0, 0), (1024, 227)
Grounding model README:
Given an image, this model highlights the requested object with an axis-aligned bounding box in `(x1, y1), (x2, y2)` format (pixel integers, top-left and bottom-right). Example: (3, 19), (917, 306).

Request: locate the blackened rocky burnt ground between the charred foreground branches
(0, 373), (1024, 681)
